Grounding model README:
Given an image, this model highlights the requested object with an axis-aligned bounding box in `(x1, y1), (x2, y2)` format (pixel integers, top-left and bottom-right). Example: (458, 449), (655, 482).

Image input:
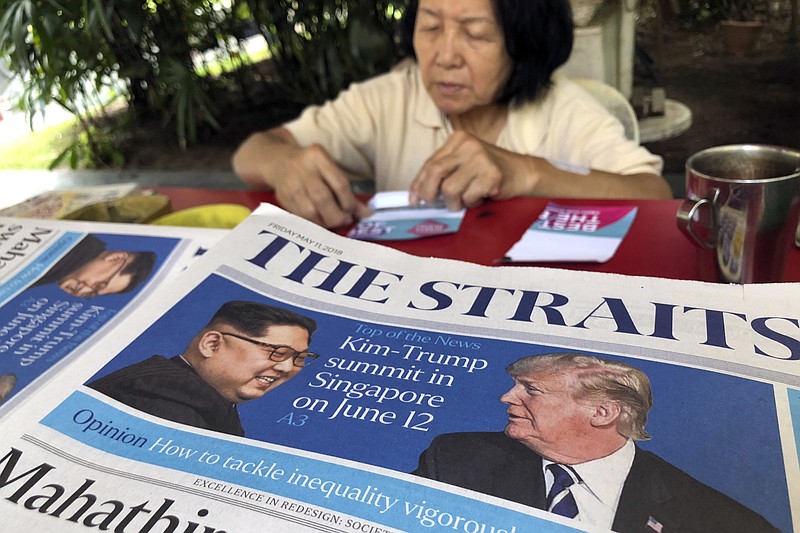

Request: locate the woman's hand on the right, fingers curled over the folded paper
(409, 131), (531, 210)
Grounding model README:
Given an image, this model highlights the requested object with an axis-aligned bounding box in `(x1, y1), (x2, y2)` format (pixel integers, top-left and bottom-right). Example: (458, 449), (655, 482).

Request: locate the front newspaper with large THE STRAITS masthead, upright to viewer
(0, 206), (800, 533)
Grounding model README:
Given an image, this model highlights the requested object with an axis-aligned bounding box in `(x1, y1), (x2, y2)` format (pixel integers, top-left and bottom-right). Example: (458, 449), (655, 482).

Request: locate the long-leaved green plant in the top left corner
(0, 0), (241, 163)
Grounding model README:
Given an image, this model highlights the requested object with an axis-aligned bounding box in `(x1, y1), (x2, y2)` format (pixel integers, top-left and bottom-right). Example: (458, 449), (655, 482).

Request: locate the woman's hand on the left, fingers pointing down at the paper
(233, 128), (369, 228)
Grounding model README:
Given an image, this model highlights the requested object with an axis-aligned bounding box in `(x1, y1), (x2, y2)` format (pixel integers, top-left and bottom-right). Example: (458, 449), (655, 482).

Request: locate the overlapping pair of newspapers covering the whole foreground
(0, 206), (800, 533)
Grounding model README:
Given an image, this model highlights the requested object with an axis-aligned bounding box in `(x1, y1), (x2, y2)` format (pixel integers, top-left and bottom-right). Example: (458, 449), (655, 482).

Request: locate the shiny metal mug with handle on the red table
(677, 144), (800, 283)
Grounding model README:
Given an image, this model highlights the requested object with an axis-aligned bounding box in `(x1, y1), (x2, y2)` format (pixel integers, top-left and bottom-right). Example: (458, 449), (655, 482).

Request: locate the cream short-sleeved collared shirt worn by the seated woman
(285, 63), (663, 191)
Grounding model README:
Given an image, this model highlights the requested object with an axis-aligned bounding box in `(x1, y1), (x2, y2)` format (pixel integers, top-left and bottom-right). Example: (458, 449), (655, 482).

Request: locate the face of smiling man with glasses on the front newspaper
(198, 325), (308, 403)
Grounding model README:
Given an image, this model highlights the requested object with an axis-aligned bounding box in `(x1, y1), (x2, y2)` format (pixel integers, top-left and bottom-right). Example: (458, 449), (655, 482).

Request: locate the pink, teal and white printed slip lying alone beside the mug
(503, 202), (637, 263)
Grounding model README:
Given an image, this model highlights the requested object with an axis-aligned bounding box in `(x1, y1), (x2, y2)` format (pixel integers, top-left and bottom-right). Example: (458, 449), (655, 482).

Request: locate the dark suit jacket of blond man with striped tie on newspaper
(413, 433), (777, 533)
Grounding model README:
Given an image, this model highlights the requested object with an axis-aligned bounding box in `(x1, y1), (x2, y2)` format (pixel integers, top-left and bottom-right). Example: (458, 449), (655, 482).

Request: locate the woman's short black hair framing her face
(400, 0), (573, 104)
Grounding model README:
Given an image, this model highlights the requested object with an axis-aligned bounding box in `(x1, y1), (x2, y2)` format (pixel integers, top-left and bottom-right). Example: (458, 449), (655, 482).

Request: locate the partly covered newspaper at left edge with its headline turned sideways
(0, 217), (227, 416)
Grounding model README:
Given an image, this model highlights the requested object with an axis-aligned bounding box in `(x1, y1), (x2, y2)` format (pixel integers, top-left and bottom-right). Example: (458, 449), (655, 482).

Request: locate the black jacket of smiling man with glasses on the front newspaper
(87, 355), (244, 437)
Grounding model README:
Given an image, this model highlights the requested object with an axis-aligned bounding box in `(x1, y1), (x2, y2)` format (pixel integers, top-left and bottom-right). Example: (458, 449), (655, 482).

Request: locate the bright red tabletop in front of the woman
(155, 187), (800, 281)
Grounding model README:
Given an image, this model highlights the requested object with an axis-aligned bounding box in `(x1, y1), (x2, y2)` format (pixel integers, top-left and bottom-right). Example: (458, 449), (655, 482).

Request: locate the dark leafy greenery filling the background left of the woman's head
(0, 0), (406, 168)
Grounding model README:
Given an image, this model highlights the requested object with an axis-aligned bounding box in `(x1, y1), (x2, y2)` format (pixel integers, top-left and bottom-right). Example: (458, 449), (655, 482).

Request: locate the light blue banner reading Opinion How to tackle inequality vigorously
(42, 392), (574, 533)
